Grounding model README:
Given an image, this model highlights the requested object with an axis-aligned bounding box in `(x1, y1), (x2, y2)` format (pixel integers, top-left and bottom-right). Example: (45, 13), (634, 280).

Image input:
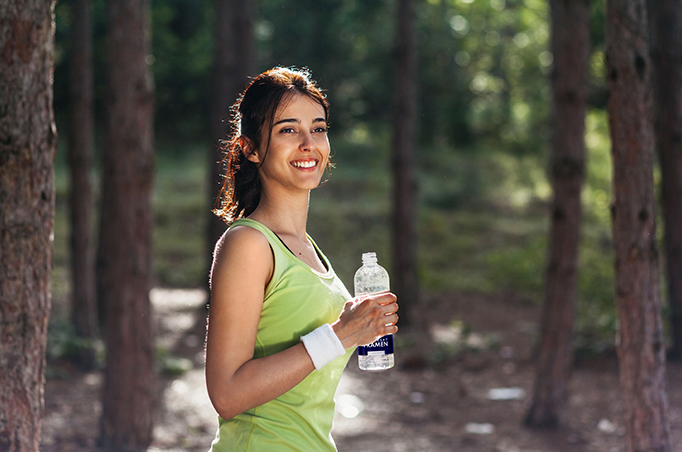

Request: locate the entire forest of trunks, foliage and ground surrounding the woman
(0, 0), (682, 452)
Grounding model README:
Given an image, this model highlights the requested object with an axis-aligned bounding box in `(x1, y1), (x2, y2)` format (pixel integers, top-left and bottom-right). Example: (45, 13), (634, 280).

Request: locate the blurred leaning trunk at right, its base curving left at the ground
(525, 0), (590, 427)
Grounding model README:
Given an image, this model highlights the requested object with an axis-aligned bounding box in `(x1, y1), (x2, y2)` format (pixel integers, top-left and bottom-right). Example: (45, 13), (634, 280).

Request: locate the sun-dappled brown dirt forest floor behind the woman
(41, 289), (682, 452)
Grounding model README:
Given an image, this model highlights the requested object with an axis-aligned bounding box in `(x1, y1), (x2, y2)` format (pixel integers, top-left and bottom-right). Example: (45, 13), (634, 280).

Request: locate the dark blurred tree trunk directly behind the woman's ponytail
(207, 0), (255, 264)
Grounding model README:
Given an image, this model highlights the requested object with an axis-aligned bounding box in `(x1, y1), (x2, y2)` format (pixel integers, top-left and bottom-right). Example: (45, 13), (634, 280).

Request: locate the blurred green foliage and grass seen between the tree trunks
(53, 0), (615, 351)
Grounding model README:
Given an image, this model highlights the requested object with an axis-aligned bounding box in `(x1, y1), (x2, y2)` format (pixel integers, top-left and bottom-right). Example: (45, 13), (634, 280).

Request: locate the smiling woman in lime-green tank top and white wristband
(206, 68), (398, 452)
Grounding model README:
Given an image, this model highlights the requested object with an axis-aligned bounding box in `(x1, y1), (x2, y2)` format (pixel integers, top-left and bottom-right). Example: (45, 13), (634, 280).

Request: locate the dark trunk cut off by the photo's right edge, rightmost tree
(649, 0), (682, 361)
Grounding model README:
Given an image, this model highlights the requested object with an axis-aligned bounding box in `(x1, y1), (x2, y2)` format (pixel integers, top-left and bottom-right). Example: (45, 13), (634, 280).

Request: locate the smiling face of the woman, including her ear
(248, 93), (329, 191)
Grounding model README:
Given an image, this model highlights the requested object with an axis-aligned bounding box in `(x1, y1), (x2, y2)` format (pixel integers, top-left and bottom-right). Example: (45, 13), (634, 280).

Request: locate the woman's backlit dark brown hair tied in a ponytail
(213, 67), (329, 224)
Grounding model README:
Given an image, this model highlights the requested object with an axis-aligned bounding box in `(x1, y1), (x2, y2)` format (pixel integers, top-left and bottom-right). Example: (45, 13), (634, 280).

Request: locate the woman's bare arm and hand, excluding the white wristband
(206, 227), (397, 419)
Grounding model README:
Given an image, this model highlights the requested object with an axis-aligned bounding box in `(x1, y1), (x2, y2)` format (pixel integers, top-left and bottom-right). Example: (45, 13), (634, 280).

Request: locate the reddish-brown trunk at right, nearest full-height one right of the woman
(606, 0), (671, 452)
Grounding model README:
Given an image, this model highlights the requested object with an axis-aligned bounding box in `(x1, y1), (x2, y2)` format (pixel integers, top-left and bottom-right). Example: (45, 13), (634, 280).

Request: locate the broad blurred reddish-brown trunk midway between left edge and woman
(98, 0), (154, 451)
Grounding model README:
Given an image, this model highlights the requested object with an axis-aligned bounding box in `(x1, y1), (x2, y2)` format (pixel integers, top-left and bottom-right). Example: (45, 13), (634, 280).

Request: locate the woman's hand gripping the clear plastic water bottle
(332, 292), (398, 349)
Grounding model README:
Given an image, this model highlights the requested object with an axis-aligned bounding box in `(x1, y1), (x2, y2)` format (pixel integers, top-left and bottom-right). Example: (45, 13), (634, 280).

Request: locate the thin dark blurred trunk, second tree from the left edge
(68, 0), (97, 370)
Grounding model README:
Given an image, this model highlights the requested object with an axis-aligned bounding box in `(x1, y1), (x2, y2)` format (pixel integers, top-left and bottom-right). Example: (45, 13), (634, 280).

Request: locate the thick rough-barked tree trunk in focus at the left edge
(0, 0), (57, 452)
